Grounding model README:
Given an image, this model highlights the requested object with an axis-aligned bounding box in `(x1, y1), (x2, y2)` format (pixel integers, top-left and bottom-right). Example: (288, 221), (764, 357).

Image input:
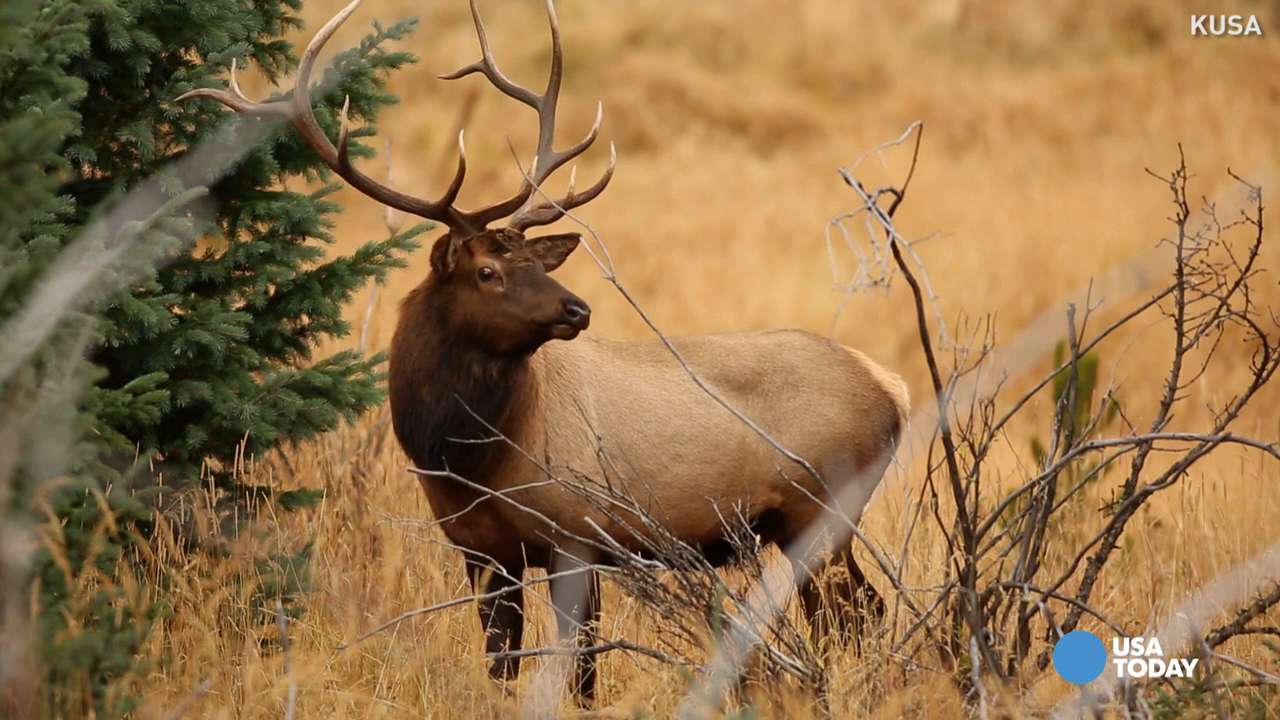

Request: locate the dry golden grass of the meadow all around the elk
(124, 0), (1280, 717)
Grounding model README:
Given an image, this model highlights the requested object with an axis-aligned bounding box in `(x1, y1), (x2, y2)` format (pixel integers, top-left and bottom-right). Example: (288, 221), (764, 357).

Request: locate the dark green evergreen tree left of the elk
(0, 0), (424, 715)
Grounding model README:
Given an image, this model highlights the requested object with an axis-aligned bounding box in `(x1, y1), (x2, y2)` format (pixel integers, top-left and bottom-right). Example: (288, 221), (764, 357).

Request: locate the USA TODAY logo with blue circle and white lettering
(1053, 630), (1199, 685)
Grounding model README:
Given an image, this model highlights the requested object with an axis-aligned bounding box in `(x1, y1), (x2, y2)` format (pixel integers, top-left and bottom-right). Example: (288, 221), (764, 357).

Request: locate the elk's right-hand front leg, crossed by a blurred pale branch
(550, 550), (600, 706)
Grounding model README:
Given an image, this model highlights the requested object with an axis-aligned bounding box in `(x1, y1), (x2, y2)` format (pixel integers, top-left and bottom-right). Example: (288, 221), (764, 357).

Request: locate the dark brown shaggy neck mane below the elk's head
(388, 281), (536, 483)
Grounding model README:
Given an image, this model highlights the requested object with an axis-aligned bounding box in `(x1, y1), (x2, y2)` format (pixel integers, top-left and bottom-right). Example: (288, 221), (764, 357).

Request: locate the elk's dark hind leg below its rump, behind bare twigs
(800, 538), (884, 646)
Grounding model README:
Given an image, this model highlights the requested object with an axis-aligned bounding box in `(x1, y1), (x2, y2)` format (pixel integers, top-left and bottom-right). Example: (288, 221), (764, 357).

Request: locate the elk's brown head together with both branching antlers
(178, 0), (617, 355)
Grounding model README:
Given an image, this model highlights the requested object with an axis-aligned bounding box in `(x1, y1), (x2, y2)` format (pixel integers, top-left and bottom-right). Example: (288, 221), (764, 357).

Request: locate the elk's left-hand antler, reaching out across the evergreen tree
(178, 0), (483, 231)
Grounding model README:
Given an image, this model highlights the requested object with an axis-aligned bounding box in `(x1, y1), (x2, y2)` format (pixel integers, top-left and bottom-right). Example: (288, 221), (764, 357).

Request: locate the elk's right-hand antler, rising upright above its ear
(440, 0), (617, 232)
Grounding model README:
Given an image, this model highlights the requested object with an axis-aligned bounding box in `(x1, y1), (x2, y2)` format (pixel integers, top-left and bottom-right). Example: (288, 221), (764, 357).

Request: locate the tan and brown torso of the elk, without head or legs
(390, 311), (906, 565)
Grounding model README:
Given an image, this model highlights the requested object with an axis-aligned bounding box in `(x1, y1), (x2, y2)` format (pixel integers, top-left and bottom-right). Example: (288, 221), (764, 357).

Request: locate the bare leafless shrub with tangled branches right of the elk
(844, 126), (1280, 715)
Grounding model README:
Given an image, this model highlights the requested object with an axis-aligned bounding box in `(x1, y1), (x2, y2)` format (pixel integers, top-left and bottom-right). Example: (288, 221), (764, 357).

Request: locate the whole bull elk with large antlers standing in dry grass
(183, 0), (908, 698)
